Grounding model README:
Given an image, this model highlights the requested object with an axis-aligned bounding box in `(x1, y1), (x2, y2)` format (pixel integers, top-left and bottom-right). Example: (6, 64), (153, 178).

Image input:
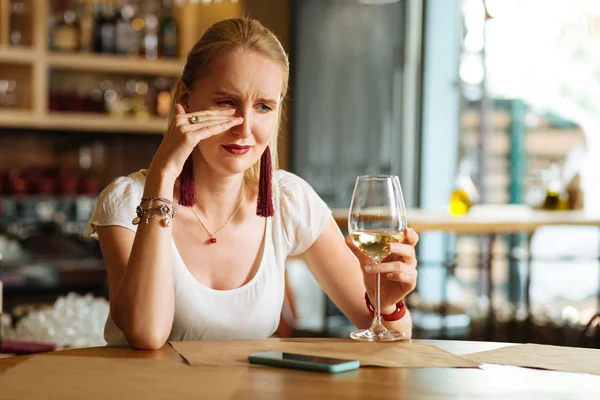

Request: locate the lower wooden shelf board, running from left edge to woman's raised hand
(0, 110), (167, 134)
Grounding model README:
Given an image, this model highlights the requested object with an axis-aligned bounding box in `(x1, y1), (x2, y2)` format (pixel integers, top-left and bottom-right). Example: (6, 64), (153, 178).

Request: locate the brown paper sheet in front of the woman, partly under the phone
(170, 339), (479, 368)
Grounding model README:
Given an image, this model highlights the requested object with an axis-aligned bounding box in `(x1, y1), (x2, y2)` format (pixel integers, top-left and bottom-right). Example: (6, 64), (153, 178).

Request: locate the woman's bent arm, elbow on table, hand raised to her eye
(97, 105), (243, 349)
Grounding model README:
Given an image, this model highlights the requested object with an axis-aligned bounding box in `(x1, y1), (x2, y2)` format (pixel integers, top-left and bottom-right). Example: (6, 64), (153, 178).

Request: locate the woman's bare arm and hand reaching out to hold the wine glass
(302, 218), (418, 338)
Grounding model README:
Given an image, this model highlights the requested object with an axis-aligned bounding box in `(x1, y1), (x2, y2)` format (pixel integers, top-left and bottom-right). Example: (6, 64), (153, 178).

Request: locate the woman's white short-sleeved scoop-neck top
(84, 170), (331, 345)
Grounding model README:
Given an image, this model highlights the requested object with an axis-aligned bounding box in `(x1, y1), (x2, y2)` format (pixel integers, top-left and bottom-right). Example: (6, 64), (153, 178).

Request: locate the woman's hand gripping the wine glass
(346, 229), (419, 314)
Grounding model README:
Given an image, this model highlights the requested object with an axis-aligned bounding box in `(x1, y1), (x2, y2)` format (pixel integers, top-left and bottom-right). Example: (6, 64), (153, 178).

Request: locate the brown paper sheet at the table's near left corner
(0, 355), (246, 400)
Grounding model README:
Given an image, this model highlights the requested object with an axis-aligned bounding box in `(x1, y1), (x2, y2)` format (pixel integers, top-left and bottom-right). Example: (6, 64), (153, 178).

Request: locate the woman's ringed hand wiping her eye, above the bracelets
(149, 104), (244, 181)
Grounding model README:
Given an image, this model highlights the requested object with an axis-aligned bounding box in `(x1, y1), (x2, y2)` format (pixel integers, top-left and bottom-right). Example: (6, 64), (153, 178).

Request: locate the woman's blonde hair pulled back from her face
(169, 18), (290, 184)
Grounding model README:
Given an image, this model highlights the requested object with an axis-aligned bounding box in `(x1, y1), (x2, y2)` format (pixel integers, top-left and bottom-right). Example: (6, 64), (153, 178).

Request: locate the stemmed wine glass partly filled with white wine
(348, 175), (407, 342)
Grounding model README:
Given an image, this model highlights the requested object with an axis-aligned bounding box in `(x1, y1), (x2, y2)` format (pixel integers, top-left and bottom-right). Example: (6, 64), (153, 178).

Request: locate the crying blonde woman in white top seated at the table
(87, 19), (417, 349)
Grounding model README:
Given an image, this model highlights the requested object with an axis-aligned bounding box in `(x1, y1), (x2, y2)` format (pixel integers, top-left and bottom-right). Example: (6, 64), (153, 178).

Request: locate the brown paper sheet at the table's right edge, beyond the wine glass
(463, 344), (600, 375)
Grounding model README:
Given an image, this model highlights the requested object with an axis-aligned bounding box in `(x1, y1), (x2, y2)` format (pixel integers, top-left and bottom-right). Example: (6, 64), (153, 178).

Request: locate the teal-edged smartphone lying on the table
(248, 351), (360, 373)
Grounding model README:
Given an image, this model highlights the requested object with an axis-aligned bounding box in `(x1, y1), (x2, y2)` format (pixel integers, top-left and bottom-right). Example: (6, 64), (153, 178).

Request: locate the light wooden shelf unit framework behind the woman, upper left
(0, 0), (227, 134)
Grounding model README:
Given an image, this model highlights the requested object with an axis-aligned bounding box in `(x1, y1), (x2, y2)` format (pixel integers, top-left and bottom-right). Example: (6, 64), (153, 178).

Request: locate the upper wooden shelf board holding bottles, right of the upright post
(48, 53), (184, 77)
